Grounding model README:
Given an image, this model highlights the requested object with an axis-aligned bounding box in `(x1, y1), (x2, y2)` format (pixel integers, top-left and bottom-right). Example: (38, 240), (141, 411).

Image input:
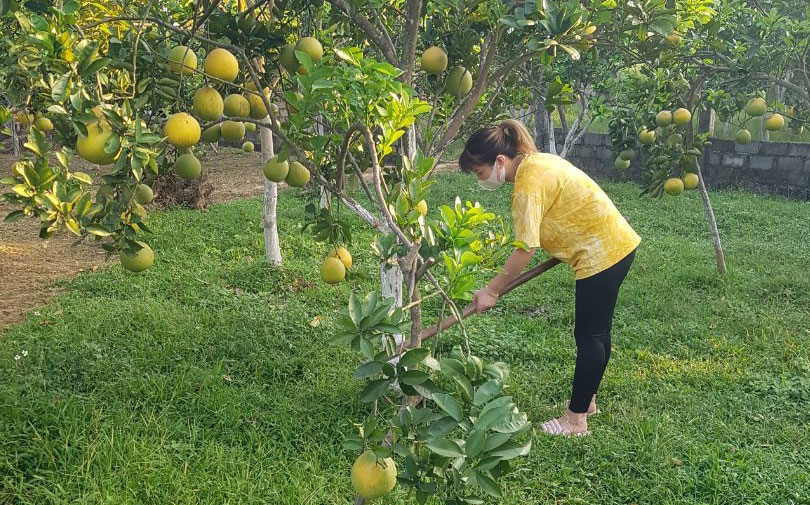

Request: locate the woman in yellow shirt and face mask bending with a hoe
(459, 120), (641, 436)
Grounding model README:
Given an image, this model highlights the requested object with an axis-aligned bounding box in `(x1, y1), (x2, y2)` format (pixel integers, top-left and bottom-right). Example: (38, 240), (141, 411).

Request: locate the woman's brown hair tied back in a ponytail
(458, 119), (537, 173)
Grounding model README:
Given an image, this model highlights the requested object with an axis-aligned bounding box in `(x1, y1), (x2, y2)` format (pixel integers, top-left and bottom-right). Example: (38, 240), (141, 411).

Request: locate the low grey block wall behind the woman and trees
(557, 132), (810, 200)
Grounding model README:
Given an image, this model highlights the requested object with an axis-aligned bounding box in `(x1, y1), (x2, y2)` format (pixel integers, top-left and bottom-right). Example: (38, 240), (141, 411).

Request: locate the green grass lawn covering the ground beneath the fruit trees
(0, 175), (810, 505)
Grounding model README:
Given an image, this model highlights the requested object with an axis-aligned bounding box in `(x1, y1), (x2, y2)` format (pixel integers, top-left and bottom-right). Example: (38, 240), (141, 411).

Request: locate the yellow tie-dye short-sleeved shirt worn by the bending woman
(512, 153), (641, 279)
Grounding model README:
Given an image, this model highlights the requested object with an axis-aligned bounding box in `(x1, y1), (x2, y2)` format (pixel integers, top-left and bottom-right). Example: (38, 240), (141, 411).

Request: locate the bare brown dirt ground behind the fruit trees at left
(0, 148), (452, 332)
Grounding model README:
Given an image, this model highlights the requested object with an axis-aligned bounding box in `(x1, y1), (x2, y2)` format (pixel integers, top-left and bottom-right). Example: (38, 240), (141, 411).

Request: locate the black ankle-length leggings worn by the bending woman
(568, 250), (636, 414)
